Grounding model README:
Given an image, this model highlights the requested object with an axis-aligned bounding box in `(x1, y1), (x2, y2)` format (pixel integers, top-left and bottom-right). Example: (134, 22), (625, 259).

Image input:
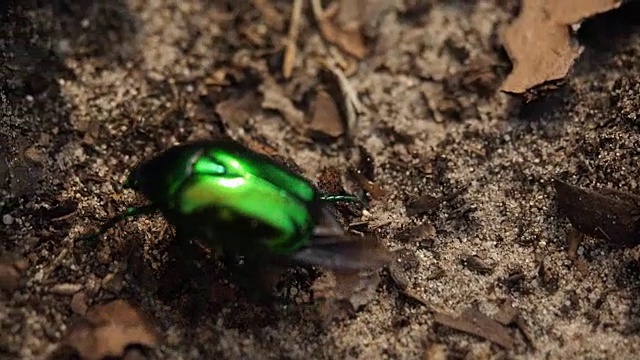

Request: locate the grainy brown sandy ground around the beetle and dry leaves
(0, 0), (640, 359)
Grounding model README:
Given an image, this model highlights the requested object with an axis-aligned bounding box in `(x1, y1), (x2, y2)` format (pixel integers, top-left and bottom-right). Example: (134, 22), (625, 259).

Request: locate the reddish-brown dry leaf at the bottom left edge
(65, 300), (160, 360)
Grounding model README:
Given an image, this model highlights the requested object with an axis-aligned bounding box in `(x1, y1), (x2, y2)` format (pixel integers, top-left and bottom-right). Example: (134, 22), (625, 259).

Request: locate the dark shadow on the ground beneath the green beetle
(121, 233), (319, 332)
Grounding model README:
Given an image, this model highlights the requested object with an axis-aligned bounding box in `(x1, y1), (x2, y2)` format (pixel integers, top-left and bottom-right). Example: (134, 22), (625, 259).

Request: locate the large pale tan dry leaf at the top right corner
(501, 0), (622, 94)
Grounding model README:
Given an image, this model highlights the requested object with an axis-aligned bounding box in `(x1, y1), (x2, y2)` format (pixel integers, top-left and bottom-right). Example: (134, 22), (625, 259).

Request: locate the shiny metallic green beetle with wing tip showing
(85, 139), (390, 271)
